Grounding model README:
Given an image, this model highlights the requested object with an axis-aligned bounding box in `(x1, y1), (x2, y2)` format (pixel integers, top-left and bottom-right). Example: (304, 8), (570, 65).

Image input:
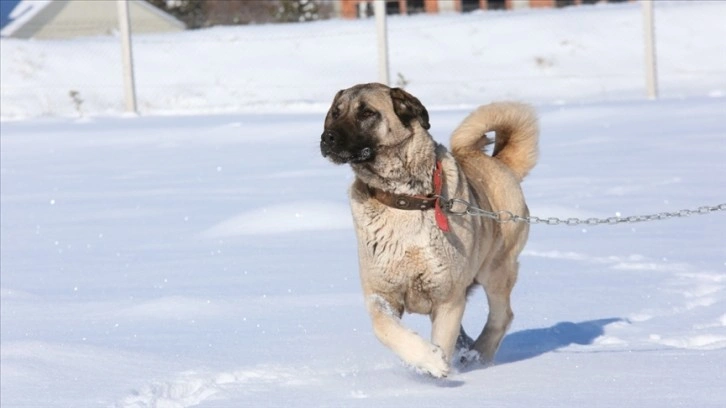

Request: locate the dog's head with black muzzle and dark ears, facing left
(320, 83), (430, 164)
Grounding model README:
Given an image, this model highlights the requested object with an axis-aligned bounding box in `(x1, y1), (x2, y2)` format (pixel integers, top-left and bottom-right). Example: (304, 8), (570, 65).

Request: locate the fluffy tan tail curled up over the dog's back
(451, 102), (539, 180)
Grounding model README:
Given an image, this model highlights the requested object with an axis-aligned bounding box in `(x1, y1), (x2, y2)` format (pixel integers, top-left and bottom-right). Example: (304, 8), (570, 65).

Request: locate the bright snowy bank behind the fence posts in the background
(0, 0), (726, 119)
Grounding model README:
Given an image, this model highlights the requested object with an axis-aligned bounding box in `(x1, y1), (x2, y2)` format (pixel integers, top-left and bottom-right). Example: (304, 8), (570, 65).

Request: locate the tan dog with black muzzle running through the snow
(320, 83), (539, 378)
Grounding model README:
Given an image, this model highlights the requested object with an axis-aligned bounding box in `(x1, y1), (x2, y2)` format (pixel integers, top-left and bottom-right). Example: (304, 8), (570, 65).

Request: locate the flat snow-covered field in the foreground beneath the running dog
(0, 94), (726, 408)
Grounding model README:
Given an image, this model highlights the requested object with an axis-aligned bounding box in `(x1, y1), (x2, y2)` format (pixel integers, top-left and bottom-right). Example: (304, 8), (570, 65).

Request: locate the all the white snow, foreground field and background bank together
(0, 2), (726, 408)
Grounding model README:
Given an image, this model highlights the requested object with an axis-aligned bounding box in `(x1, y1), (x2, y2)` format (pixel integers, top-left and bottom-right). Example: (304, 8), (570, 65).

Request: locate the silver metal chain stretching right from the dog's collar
(440, 197), (726, 226)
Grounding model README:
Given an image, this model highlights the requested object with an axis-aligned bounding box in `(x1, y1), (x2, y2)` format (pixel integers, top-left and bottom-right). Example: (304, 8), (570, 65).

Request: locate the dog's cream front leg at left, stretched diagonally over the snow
(366, 294), (458, 378)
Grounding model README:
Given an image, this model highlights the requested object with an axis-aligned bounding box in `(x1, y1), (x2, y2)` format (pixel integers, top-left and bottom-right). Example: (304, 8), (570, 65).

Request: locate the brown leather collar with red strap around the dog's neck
(368, 160), (449, 232)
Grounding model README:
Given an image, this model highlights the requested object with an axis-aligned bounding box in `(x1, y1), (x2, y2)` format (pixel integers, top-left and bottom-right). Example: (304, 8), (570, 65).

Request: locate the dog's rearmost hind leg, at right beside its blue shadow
(473, 261), (519, 365)
